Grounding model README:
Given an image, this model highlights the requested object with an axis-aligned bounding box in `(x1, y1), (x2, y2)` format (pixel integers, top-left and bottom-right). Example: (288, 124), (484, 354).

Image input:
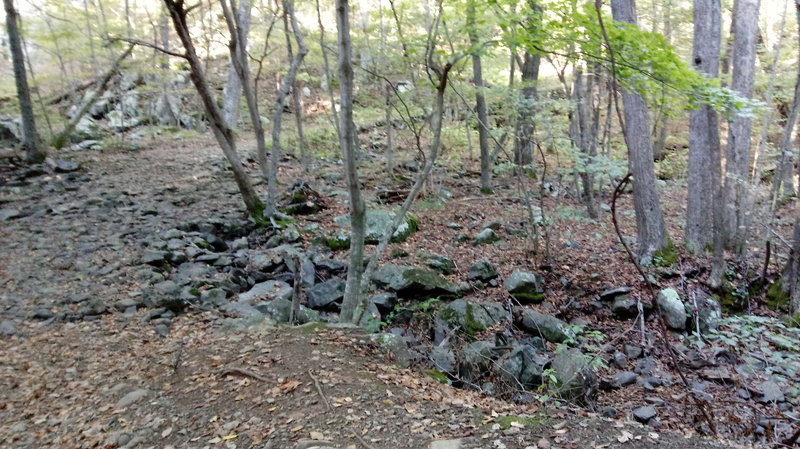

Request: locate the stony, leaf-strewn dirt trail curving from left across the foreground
(0, 141), (740, 449)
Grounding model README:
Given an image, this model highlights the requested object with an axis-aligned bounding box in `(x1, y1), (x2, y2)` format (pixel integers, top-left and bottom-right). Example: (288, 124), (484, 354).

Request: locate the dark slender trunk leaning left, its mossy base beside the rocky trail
(164, 0), (264, 220)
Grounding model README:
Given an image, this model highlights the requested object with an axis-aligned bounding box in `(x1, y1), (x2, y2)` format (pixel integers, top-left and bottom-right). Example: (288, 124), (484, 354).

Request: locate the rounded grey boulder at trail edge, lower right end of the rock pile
(550, 348), (598, 402)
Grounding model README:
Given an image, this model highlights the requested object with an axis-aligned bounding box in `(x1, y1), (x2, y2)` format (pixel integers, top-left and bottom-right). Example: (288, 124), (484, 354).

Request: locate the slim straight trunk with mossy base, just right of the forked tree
(467, 0), (492, 193)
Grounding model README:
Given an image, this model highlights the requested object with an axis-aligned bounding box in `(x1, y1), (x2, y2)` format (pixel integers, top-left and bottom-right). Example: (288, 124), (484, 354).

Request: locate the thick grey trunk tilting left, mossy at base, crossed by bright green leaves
(611, 0), (669, 264)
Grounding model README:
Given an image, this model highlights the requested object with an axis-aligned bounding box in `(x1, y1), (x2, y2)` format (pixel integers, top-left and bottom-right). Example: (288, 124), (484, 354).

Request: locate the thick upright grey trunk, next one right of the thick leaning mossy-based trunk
(686, 0), (722, 253)
